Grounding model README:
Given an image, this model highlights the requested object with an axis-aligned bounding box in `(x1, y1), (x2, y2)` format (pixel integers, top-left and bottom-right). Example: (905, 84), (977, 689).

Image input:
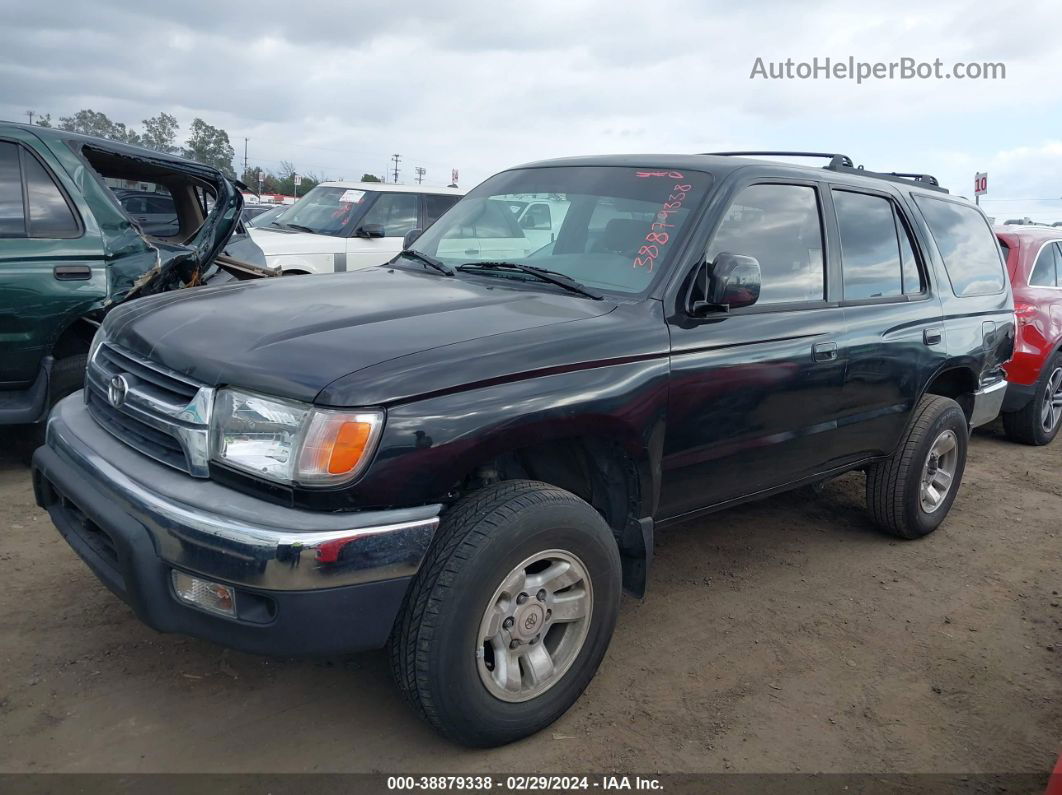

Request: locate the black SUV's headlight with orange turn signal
(210, 390), (383, 486)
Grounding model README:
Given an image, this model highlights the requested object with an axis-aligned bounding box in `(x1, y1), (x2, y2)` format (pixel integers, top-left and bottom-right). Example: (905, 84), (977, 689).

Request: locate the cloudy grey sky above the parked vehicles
(6, 0), (1062, 221)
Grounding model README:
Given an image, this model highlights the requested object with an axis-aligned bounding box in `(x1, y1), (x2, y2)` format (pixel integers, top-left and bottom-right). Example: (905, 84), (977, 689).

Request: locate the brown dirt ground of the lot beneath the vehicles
(0, 427), (1062, 774)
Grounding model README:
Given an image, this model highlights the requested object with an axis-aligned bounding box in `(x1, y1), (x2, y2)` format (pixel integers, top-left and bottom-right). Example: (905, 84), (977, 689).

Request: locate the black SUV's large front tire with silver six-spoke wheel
(389, 481), (621, 747)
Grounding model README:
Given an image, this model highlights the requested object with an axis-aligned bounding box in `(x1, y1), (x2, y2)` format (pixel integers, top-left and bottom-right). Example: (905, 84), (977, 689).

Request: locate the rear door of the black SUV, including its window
(830, 186), (945, 462)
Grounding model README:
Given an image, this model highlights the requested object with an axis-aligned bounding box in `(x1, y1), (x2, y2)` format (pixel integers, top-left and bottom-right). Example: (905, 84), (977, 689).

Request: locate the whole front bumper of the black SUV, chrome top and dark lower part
(33, 393), (440, 654)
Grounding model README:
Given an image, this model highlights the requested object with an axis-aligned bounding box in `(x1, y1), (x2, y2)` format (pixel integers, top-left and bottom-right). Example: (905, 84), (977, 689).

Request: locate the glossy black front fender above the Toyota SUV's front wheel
(343, 357), (669, 518)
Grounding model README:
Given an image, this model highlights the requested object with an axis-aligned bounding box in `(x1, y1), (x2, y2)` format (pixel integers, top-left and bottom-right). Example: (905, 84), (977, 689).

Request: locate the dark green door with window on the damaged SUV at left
(0, 136), (107, 388)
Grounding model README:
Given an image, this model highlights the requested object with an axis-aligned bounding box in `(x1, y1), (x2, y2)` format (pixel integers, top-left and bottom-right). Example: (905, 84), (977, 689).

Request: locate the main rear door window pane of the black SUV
(834, 191), (904, 300)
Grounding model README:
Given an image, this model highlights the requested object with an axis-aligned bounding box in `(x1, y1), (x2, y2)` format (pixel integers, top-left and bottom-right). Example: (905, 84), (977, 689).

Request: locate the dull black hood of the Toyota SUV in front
(105, 267), (616, 402)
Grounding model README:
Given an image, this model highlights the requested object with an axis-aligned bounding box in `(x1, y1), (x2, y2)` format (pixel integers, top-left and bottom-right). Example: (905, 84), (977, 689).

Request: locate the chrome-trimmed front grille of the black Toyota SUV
(85, 343), (213, 478)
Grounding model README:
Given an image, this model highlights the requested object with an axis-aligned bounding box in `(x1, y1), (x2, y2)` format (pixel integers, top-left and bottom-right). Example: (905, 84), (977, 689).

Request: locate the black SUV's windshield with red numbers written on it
(413, 166), (712, 293)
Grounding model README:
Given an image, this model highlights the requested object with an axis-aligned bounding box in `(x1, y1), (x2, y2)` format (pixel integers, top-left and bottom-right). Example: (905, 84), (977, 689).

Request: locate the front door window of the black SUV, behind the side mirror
(707, 185), (825, 305)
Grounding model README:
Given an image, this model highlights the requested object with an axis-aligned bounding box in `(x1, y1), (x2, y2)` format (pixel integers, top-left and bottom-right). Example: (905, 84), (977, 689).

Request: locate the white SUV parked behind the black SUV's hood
(249, 183), (463, 274)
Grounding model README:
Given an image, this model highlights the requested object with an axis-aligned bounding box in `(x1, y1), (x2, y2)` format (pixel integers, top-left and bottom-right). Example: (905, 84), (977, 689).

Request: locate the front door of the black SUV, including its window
(660, 180), (844, 518)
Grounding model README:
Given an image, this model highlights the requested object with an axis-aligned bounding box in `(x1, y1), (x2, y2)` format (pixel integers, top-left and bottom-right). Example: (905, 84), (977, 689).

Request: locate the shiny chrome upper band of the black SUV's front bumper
(45, 394), (442, 590)
